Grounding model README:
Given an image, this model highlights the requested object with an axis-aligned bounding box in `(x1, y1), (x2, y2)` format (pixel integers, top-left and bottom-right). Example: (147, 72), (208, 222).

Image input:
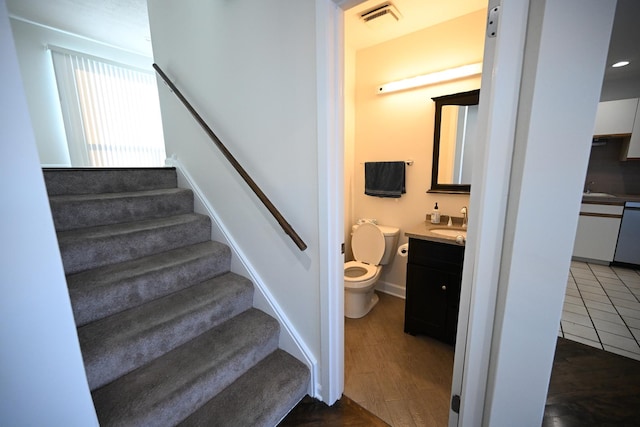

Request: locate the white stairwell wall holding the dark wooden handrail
(149, 0), (322, 392)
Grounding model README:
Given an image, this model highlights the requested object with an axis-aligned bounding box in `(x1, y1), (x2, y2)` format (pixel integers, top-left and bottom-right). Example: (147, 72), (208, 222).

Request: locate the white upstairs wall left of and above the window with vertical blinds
(11, 18), (152, 167)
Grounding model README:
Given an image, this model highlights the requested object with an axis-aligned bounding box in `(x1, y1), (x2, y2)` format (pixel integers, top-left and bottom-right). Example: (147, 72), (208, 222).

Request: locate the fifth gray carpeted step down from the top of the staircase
(78, 273), (253, 390)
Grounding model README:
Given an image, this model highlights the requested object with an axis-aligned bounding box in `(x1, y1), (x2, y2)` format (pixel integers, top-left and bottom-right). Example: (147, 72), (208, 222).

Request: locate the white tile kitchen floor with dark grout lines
(558, 261), (640, 360)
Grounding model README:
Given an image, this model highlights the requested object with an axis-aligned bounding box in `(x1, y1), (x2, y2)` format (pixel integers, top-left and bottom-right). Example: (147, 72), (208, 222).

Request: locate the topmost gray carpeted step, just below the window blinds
(42, 168), (178, 196)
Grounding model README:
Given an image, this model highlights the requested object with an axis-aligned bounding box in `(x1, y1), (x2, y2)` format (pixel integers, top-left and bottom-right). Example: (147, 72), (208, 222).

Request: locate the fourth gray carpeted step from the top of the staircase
(67, 241), (231, 326)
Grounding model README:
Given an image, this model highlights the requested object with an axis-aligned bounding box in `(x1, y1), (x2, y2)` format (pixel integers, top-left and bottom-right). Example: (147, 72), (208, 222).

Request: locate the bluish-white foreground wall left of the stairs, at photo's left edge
(0, 0), (98, 427)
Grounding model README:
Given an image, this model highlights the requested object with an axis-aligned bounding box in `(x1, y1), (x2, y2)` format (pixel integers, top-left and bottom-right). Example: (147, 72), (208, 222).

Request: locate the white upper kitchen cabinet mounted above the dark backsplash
(593, 98), (640, 136)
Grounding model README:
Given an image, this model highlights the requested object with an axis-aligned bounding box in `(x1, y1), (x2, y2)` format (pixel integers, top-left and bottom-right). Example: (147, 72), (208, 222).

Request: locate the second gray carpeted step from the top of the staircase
(49, 188), (193, 231)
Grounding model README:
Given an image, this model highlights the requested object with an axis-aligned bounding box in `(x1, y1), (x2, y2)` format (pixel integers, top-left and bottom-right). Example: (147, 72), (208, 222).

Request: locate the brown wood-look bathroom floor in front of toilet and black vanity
(344, 293), (453, 427)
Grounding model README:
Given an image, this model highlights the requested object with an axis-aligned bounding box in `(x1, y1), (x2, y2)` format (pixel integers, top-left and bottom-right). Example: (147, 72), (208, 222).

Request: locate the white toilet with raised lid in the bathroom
(344, 222), (400, 319)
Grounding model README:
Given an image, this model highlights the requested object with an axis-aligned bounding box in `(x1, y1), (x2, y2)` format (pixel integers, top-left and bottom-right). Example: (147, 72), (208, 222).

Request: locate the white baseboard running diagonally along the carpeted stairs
(166, 156), (320, 397)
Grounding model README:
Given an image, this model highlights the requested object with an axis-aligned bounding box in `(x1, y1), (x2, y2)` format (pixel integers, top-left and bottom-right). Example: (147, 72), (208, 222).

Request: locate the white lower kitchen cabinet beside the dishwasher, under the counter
(573, 202), (624, 264)
